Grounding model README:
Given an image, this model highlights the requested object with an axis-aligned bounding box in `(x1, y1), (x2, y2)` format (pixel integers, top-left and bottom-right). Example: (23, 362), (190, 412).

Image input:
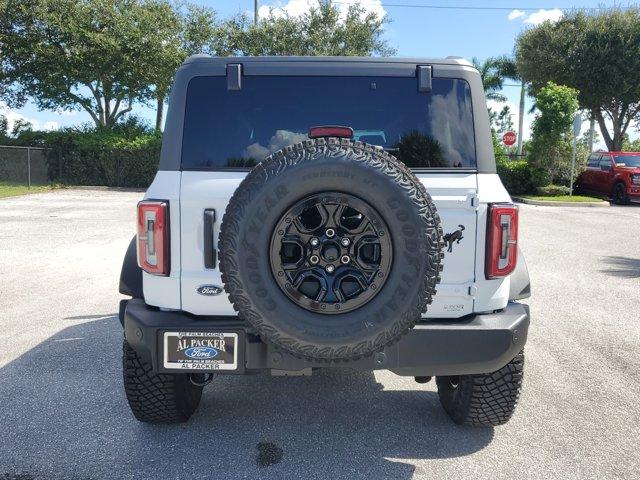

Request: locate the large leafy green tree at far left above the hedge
(0, 0), (173, 128)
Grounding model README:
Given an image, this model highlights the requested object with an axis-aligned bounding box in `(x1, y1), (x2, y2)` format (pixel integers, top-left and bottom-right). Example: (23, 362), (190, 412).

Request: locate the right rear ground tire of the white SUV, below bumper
(436, 352), (524, 427)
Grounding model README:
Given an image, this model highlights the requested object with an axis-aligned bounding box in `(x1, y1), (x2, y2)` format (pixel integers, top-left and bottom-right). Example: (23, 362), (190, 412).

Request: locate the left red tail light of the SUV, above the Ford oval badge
(138, 200), (169, 275)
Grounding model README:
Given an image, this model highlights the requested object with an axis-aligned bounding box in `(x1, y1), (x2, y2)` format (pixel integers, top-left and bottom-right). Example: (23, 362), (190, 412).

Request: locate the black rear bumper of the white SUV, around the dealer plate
(121, 299), (529, 376)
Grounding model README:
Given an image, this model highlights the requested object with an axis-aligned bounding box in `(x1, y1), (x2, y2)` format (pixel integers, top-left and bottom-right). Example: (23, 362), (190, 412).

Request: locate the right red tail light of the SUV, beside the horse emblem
(485, 204), (518, 279)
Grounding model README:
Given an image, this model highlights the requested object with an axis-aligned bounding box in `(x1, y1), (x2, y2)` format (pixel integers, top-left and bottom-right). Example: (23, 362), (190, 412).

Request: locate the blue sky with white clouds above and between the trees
(0, 0), (638, 146)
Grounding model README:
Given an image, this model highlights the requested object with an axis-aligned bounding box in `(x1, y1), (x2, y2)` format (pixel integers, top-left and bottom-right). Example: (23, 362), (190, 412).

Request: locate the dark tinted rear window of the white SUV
(182, 76), (476, 170)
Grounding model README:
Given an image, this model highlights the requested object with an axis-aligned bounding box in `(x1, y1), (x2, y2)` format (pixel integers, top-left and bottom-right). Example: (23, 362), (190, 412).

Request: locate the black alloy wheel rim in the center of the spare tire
(270, 192), (393, 314)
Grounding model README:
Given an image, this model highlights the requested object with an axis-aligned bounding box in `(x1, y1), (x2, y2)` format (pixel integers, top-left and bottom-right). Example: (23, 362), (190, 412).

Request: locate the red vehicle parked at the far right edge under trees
(576, 152), (640, 205)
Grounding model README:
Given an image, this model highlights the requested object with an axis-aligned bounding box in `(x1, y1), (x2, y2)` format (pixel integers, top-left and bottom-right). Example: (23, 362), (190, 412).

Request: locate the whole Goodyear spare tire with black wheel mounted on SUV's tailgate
(219, 138), (443, 361)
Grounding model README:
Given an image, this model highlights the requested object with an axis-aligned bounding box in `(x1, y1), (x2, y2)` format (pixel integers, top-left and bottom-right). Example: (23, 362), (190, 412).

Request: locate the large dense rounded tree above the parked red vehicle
(516, 8), (640, 150)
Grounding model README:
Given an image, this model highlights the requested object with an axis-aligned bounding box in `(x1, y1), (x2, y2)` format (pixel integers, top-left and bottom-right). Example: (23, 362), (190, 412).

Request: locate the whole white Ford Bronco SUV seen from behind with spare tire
(120, 55), (529, 426)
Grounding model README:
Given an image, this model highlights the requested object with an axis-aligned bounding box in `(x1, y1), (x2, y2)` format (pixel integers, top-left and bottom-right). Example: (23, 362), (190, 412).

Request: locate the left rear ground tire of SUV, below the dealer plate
(122, 340), (202, 423)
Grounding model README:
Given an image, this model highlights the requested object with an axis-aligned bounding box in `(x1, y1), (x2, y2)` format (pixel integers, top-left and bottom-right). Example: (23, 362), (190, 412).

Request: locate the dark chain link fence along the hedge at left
(0, 145), (160, 188)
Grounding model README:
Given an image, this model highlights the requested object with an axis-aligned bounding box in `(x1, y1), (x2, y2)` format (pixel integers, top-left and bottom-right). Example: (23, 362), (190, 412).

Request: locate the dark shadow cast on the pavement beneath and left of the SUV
(0, 316), (493, 479)
